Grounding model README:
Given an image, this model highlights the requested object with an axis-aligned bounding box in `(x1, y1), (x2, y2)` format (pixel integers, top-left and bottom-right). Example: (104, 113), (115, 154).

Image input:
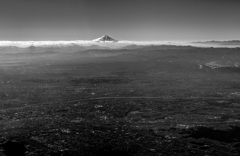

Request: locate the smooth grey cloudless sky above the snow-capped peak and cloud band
(0, 0), (240, 41)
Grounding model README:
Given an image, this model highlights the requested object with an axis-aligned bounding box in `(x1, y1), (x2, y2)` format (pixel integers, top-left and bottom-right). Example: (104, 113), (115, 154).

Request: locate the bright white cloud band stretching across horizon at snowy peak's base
(0, 40), (239, 48)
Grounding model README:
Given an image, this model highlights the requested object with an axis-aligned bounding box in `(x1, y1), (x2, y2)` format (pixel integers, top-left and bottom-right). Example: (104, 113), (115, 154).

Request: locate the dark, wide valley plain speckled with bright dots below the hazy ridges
(0, 47), (240, 156)
